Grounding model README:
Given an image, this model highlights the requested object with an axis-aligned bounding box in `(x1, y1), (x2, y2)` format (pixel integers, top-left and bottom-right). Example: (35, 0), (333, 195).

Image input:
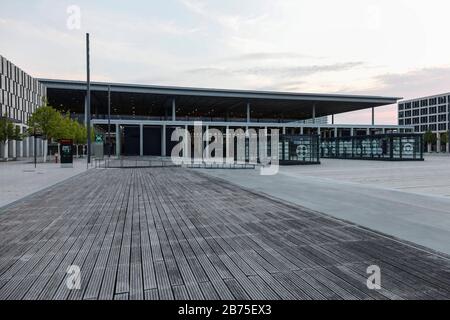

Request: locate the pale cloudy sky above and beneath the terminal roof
(0, 0), (450, 124)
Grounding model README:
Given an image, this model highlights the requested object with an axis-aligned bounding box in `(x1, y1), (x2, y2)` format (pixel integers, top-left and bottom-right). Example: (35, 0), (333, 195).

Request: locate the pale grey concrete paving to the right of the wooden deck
(203, 155), (450, 254)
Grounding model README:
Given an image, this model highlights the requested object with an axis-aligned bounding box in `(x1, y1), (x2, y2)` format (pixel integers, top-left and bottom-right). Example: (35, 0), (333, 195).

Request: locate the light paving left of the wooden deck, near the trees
(0, 159), (91, 208)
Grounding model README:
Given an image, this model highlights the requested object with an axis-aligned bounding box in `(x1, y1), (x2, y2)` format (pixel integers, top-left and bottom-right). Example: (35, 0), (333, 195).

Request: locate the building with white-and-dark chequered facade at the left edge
(0, 55), (46, 158)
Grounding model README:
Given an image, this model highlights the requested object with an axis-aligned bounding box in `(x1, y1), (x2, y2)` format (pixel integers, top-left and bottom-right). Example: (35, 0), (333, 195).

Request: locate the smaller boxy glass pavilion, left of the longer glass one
(278, 135), (320, 165)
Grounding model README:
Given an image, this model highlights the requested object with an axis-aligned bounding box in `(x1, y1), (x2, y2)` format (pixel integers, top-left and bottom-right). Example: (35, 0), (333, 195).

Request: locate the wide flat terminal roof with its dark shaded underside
(39, 79), (401, 120)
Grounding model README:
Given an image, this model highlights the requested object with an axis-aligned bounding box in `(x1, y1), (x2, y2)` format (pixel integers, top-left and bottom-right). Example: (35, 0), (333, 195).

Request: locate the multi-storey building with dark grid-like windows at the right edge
(398, 93), (450, 152)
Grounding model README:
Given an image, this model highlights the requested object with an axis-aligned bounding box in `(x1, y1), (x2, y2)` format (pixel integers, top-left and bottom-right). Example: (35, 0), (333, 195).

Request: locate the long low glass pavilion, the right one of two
(320, 133), (423, 161)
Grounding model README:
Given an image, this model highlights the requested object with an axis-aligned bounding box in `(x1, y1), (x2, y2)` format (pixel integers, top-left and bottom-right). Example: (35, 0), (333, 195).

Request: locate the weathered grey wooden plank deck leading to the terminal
(0, 168), (450, 299)
